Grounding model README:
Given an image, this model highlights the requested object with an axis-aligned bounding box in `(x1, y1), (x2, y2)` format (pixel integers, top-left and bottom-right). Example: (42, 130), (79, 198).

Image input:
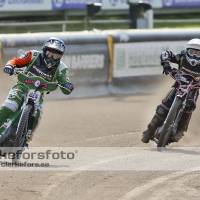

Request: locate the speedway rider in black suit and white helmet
(141, 38), (200, 143)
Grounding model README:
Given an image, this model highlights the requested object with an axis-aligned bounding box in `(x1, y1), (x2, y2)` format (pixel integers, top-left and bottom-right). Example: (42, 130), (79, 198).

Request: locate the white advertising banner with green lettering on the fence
(113, 40), (188, 78)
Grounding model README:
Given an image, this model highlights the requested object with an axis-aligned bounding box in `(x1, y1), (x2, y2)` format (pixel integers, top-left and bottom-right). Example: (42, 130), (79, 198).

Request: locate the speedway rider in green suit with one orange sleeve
(0, 37), (74, 139)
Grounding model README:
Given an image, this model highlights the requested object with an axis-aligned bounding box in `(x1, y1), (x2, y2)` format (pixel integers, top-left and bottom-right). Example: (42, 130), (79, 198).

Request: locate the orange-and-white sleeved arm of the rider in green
(6, 50), (38, 68)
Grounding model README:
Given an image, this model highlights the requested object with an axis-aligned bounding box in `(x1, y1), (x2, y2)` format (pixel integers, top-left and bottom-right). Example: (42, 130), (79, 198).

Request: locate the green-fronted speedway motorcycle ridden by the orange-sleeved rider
(0, 68), (66, 164)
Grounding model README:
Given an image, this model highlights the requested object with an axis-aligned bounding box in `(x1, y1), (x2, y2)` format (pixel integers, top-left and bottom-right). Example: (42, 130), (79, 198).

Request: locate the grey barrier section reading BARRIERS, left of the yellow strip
(0, 32), (110, 98)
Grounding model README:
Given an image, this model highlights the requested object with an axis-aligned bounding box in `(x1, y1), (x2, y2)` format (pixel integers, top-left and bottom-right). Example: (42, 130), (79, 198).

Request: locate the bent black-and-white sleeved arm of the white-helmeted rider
(160, 50), (185, 65)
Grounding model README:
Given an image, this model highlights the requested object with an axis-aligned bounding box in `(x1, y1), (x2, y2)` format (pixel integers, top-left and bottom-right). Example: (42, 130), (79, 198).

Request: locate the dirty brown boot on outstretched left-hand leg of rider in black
(141, 115), (163, 143)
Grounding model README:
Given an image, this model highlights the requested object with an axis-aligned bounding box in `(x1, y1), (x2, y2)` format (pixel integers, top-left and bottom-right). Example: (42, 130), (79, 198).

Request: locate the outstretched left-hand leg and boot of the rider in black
(141, 84), (177, 143)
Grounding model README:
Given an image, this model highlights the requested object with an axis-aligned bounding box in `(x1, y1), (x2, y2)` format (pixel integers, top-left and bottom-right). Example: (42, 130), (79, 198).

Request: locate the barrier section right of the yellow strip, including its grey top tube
(106, 29), (200, 79)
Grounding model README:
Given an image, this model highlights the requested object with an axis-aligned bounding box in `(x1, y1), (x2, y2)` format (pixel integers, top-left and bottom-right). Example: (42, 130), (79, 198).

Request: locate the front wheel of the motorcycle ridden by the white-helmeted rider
(157, 98), (182, 147)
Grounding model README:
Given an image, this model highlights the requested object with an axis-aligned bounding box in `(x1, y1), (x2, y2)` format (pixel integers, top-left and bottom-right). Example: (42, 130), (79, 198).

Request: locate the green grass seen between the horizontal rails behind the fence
(0, 13), (200, 34)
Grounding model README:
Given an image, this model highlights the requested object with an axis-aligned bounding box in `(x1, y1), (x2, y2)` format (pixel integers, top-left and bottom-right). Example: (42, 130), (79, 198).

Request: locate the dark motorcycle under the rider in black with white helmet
(152, 68), (200, 148)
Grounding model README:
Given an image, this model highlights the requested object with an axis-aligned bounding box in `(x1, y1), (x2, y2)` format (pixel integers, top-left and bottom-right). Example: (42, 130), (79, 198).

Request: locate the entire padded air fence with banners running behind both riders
(0, 29), (200, 99)
